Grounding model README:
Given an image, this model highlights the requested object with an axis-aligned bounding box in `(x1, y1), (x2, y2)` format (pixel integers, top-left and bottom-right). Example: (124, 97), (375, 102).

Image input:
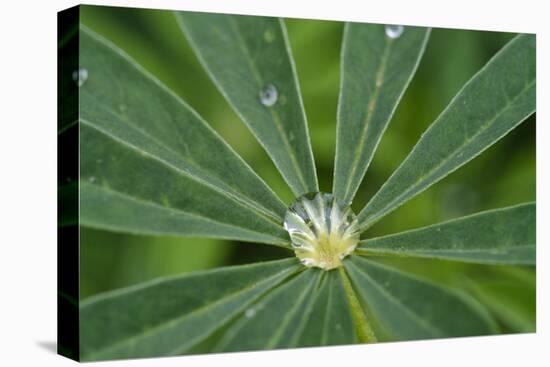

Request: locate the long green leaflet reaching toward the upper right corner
(359, 35), (536, 229)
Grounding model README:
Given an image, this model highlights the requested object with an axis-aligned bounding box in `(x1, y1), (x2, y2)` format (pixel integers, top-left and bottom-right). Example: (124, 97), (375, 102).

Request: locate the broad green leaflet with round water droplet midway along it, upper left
(176, 12), (319, 196)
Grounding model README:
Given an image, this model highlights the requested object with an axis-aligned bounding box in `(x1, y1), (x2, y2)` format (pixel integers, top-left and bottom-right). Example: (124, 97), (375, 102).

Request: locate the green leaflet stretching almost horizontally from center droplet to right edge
(356, 203), (536, 265)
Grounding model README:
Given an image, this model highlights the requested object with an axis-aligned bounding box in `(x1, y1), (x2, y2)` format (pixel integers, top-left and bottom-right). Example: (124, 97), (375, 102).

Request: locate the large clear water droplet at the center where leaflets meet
(284, 192), (359, 270)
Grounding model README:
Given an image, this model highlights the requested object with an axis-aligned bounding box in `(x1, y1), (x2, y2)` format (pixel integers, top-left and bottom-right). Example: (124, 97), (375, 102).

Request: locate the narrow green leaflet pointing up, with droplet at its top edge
(333, 23), (430, 204)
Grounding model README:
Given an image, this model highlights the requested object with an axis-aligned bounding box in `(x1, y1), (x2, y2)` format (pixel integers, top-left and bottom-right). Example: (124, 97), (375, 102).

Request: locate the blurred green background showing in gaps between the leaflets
(80, 6), (535, 332)
